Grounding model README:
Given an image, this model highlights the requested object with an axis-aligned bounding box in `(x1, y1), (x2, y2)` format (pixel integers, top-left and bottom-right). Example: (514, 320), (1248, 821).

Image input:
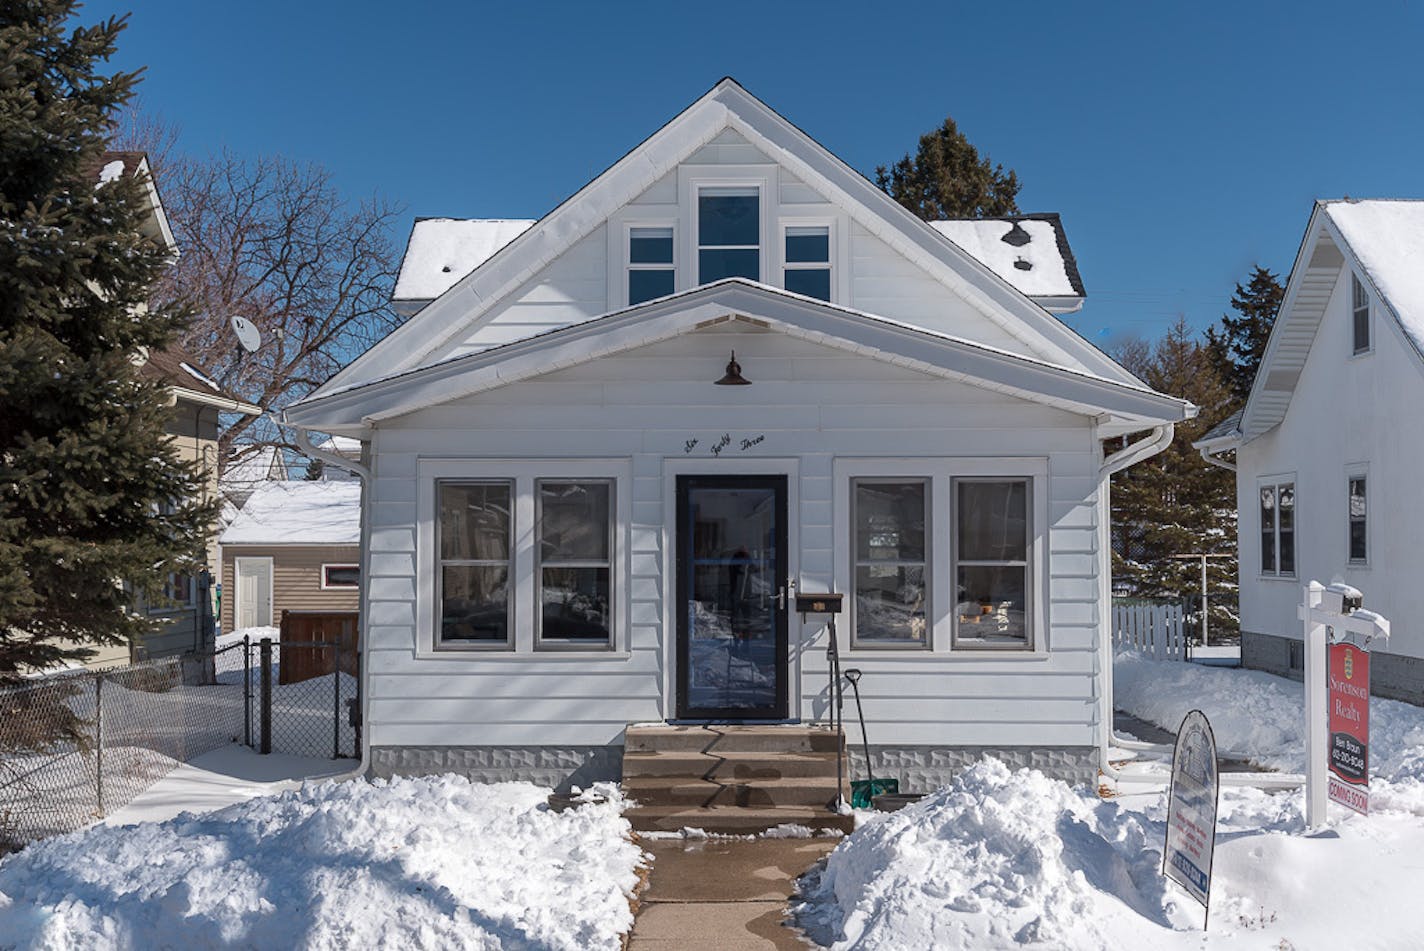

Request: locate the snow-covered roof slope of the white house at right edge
(1321, 198), (1424, 352)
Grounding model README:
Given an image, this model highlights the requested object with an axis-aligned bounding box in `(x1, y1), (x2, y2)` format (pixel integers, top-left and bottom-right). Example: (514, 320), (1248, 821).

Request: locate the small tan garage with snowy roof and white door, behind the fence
(221, 480), (360, 631)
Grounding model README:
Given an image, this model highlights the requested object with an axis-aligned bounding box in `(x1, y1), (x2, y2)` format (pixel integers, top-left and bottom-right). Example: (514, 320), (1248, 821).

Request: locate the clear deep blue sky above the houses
(91, 0), (1424, 346)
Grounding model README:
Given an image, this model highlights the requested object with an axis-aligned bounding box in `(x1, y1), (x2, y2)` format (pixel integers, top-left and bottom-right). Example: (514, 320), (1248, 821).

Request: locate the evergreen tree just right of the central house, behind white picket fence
(1108, 317), (1239, 632)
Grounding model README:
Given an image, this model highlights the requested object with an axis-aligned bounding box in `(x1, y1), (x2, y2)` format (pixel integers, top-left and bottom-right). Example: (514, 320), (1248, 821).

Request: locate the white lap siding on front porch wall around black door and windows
(366, 325), (1102, 746)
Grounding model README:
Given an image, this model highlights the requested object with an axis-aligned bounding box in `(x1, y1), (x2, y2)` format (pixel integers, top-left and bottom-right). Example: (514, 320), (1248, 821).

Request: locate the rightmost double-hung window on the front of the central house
(951, 478), (1032, 649)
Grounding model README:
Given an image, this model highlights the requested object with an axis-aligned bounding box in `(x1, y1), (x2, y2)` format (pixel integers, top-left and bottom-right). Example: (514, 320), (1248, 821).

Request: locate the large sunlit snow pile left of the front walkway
(0, 776), (642, 950)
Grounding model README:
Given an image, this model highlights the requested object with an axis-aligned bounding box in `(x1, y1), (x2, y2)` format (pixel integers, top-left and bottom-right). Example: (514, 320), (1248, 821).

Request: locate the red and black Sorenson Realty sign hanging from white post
(1326, 642), (1370, 816)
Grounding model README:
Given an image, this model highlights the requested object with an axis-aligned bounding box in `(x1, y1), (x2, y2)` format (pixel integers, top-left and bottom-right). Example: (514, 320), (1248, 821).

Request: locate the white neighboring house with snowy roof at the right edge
(1196, 199), (1424, 703)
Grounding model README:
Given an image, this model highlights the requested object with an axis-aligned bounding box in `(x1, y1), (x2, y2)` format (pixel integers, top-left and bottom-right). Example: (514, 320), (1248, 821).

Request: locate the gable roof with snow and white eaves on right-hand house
(1218, 199), (1424, 443)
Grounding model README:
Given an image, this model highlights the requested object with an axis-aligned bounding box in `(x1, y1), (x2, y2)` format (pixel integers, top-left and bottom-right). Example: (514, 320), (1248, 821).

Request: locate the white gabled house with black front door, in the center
(285, 80), (1193, 789)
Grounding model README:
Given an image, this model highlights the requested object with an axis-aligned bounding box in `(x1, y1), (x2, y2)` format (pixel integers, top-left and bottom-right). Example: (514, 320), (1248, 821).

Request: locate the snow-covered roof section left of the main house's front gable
(392, 218), (534, 300)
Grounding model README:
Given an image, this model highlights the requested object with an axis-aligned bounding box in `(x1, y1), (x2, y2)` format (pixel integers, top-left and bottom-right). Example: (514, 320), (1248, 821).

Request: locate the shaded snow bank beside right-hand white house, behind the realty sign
(1112, 653), (1424, 785)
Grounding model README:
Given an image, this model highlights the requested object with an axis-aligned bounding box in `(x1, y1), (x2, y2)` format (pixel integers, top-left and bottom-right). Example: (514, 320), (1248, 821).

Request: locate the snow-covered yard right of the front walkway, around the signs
(799, 655), (1424, 951)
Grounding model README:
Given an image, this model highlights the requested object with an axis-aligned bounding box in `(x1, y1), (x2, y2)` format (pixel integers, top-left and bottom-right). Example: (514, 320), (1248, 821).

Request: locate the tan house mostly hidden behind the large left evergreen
(88, 152), (261, 666)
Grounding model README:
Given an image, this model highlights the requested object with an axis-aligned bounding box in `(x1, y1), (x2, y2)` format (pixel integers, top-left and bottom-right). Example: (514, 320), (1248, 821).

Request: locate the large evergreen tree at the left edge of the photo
(0, 0), (215, 679)
